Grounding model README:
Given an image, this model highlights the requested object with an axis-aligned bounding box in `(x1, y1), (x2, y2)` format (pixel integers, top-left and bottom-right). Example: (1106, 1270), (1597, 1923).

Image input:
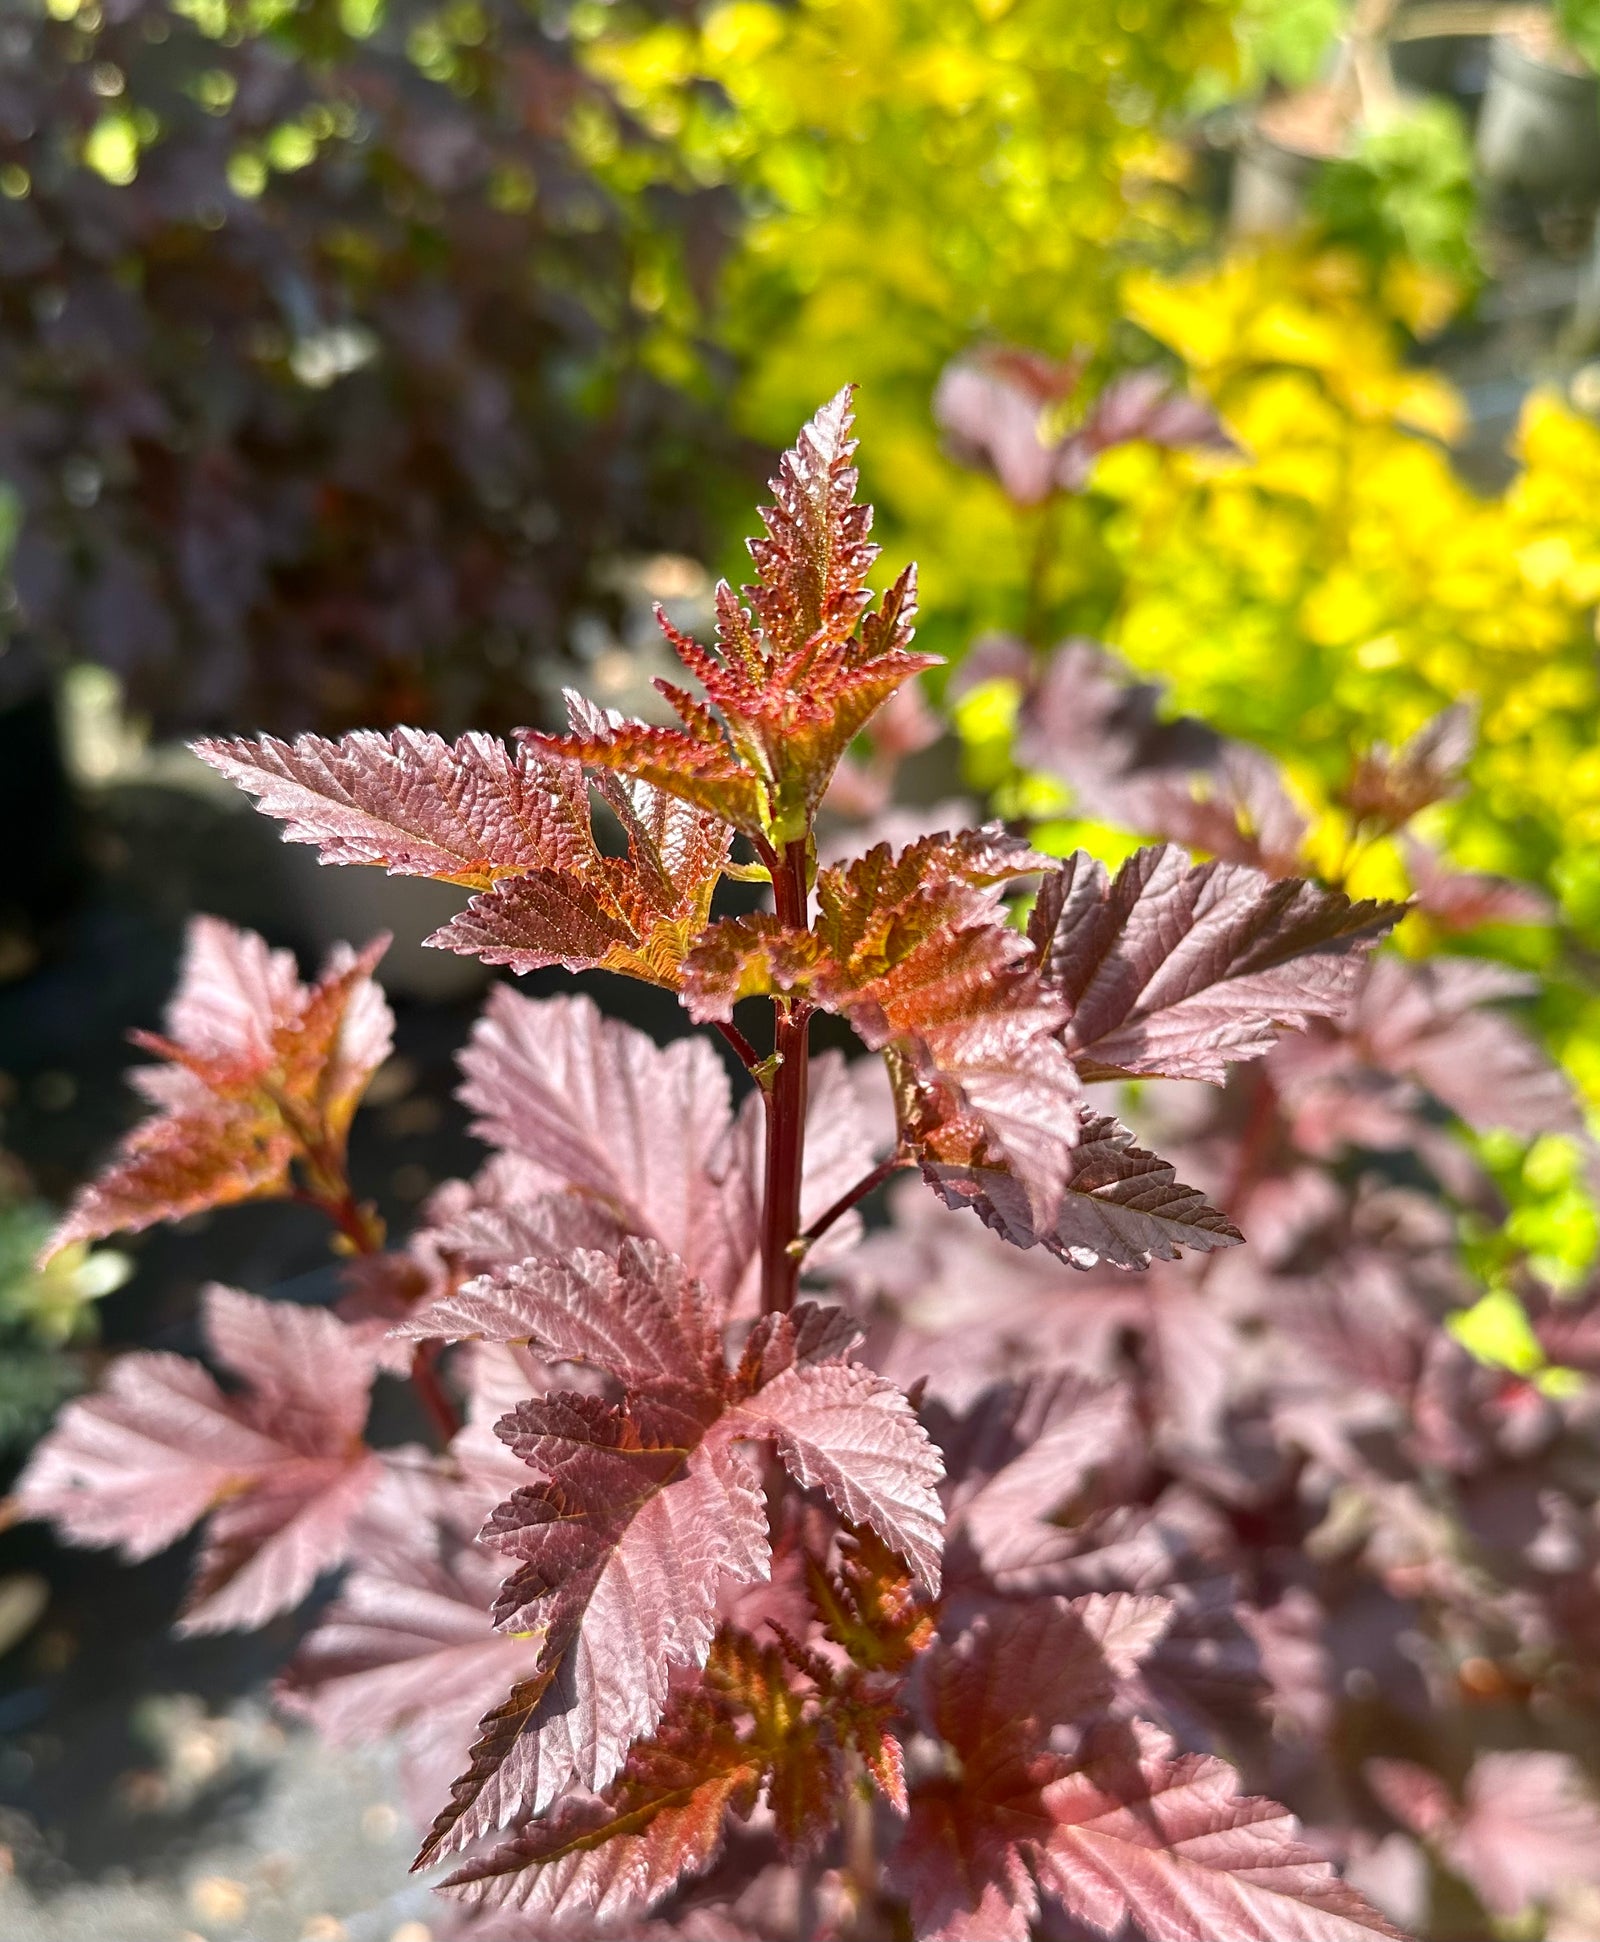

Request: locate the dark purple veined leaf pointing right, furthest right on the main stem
(1029, 845), (1402, 1080)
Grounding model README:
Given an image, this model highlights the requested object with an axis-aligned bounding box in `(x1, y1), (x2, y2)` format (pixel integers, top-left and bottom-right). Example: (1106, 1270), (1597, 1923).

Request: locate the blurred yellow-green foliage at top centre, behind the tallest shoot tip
(584, 0), (1237, 653)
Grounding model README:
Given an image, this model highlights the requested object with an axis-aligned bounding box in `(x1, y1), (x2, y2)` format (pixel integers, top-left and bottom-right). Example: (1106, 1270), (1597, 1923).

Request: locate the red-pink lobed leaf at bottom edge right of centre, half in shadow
(893, 1596), (1398, 1942)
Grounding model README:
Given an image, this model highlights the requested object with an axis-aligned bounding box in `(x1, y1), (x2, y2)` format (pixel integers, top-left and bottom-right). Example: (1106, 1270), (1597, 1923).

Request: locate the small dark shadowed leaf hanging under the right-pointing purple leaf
(922, 1115), (1245, 1268)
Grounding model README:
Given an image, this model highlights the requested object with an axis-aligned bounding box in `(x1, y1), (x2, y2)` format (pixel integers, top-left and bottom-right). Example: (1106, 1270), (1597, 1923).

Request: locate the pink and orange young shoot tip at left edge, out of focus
(45, 917), (394, 1258)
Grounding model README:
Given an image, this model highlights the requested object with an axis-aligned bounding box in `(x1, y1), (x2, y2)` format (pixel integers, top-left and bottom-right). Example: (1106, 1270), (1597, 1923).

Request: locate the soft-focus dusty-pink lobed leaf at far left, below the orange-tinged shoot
(17, 1288), (381, 1631)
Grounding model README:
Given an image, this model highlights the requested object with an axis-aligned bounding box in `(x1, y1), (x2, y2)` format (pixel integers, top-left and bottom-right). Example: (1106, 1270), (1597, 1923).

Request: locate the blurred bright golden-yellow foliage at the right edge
(1097, 251), (1600, 971)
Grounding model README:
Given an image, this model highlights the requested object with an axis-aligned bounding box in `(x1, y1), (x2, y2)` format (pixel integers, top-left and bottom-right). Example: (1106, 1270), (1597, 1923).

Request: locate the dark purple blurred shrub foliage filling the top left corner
(0, 0), (741, 728)
